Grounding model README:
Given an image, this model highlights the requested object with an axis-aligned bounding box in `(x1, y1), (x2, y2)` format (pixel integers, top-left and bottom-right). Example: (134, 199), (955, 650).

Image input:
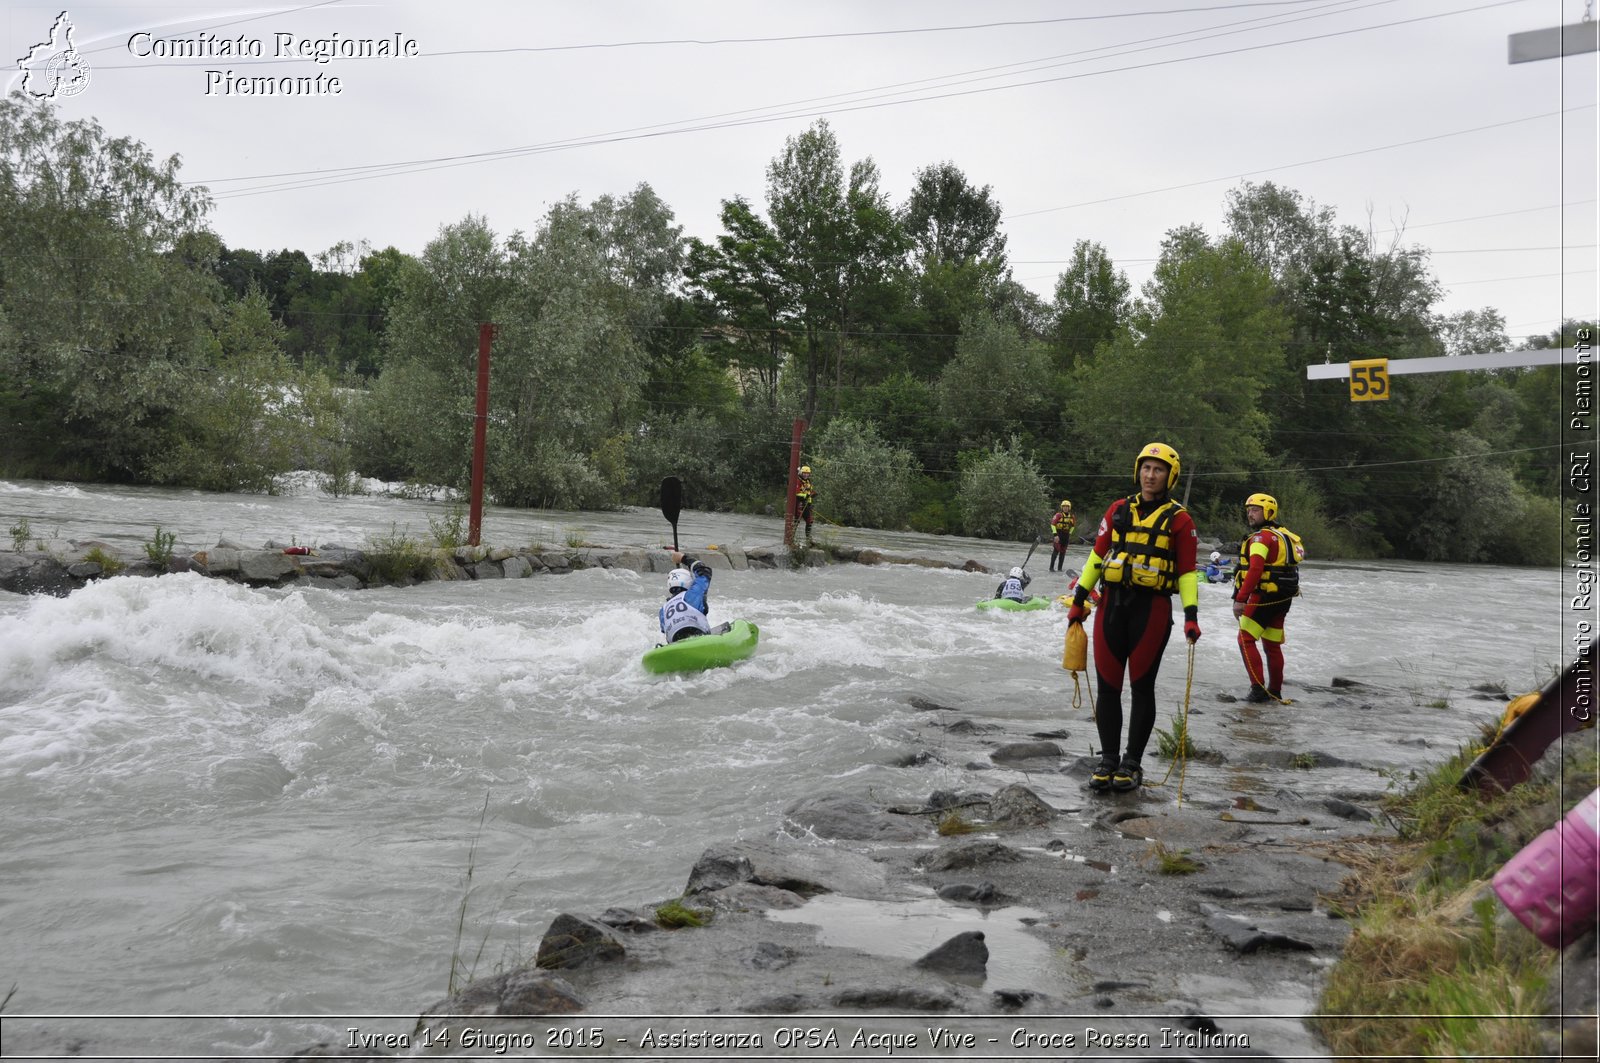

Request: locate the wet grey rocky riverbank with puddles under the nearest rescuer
(284, 675), (1523, 1060)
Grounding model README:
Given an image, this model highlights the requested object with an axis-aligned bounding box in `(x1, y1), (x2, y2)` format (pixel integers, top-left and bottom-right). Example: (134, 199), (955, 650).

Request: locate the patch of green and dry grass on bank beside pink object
(1310, 749), (1597, 1058)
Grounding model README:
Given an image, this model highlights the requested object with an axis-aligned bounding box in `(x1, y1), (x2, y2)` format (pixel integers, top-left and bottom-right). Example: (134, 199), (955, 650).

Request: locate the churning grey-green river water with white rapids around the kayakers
(0, 482), (1562, 1058)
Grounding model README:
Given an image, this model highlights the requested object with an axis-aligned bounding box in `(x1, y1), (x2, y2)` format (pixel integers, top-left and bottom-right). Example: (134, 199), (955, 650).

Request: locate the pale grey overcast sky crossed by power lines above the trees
(0, 0), (1597, 339)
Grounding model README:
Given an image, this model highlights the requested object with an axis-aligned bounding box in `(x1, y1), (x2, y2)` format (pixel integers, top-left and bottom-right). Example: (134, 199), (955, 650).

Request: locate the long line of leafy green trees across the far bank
(0, 94), (1578, 564)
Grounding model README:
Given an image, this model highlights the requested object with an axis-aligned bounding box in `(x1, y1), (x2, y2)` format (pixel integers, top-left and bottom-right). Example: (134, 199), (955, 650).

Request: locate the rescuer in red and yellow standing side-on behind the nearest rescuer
(1234, 493), (1302, 701)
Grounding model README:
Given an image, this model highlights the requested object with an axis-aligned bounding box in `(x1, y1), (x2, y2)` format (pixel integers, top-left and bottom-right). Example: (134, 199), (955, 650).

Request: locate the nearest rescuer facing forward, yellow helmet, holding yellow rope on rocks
(1067, 443), (1200, 791)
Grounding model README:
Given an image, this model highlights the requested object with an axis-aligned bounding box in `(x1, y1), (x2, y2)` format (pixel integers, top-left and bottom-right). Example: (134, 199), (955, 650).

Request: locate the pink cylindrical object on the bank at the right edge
(1493, 789), (1600, 949)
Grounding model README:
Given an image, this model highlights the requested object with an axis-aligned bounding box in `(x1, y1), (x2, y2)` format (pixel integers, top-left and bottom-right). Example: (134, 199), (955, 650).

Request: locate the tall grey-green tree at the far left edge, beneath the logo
(0, 93), (221, 479)
